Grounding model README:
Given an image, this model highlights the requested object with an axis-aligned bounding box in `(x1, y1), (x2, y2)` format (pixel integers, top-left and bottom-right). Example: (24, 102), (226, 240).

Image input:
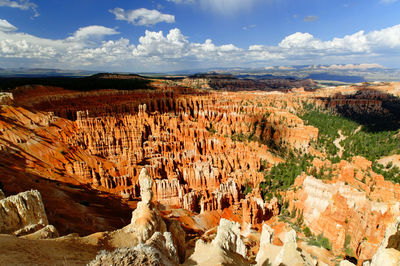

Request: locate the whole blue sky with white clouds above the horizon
(0, 0), (400, 73)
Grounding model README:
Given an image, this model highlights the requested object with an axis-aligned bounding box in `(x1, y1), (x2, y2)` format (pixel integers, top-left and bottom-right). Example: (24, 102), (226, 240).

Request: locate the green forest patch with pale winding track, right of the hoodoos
(300, 103), (400, 183)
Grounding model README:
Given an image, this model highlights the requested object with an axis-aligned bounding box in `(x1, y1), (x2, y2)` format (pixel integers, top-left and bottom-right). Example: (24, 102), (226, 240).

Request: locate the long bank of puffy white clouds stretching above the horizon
(0, 23), (400, 71)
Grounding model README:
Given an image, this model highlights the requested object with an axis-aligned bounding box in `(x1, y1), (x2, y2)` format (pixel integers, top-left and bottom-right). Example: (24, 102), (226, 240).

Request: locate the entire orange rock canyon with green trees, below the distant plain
(0, 75), (400, 265)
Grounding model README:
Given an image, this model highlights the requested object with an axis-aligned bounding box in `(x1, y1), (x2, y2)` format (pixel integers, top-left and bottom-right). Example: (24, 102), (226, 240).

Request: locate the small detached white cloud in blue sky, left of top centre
(110, 7), (175, 26)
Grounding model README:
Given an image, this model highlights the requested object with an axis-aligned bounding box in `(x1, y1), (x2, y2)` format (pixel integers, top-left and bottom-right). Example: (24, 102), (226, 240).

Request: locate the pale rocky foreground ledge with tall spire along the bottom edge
(0, 167), (400, 266)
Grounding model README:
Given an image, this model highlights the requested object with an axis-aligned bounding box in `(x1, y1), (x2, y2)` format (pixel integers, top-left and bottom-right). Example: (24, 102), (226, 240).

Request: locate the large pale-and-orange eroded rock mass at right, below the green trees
(288, 158), (400, 260)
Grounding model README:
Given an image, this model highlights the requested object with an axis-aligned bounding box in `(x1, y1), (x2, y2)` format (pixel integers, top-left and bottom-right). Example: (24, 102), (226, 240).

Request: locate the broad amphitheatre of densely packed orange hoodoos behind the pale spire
(0, 86), (317, 220)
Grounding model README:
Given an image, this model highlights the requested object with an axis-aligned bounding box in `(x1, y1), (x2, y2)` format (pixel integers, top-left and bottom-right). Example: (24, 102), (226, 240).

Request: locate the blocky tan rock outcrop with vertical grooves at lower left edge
(0, 190), (49, 235)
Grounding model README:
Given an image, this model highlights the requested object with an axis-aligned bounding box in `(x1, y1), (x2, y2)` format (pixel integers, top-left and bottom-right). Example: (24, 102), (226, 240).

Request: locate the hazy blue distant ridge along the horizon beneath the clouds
(0, 64), (400, 83)
